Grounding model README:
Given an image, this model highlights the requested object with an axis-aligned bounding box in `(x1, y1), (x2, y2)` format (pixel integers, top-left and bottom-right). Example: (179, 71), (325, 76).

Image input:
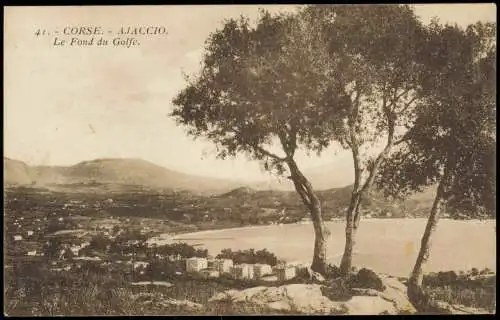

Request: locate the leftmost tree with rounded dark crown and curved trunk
(172, 11), (349, 274)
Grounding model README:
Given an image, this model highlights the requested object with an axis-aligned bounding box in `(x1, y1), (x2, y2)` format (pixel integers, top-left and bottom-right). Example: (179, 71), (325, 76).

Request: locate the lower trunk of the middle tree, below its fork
(340, 191), (361, 276)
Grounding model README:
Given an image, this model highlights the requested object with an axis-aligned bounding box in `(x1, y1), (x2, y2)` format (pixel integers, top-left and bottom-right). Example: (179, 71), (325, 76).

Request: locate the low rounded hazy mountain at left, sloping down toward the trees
(4, 158), (243, 193)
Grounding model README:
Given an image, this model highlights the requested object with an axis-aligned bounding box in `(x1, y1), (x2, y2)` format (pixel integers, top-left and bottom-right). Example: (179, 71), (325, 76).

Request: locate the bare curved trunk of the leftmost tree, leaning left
(287, 159), (329, 275)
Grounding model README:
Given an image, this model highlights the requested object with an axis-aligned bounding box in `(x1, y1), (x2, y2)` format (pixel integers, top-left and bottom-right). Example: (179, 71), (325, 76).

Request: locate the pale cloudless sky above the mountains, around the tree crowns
(4, 4), (496, 181)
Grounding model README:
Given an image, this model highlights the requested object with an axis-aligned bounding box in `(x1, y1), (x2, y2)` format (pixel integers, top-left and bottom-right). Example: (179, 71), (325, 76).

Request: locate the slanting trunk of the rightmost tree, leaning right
(408, 179), (446, 311)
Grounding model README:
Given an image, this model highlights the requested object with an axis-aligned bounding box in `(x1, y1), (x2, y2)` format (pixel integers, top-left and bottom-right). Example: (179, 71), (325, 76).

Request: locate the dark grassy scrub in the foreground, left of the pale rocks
(4, 262), (288, 316)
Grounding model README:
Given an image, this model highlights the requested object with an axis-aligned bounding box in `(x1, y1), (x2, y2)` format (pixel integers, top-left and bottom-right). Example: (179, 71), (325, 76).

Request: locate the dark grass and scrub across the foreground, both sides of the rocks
(4, 261), (496, 316)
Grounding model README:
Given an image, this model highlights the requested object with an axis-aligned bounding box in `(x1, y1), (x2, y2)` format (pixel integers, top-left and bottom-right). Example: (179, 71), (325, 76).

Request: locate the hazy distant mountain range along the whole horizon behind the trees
(4, 157), (435, 208)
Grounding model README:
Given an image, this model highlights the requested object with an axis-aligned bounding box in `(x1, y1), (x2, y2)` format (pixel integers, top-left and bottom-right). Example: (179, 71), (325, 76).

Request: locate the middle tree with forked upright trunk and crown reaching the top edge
(304, 5), (424, 275)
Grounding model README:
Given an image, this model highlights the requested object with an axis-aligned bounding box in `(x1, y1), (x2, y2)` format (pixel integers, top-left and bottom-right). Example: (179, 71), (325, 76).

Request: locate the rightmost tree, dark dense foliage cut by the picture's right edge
(377, 21), (496, 309)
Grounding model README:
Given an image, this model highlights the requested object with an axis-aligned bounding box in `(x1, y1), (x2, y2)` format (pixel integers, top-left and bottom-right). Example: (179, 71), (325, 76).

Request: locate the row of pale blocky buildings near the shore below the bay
(186, 257), (305, 281)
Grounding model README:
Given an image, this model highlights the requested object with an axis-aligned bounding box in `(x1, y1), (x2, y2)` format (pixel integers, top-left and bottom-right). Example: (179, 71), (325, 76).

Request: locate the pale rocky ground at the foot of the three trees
(126, 274), (488, 315)
